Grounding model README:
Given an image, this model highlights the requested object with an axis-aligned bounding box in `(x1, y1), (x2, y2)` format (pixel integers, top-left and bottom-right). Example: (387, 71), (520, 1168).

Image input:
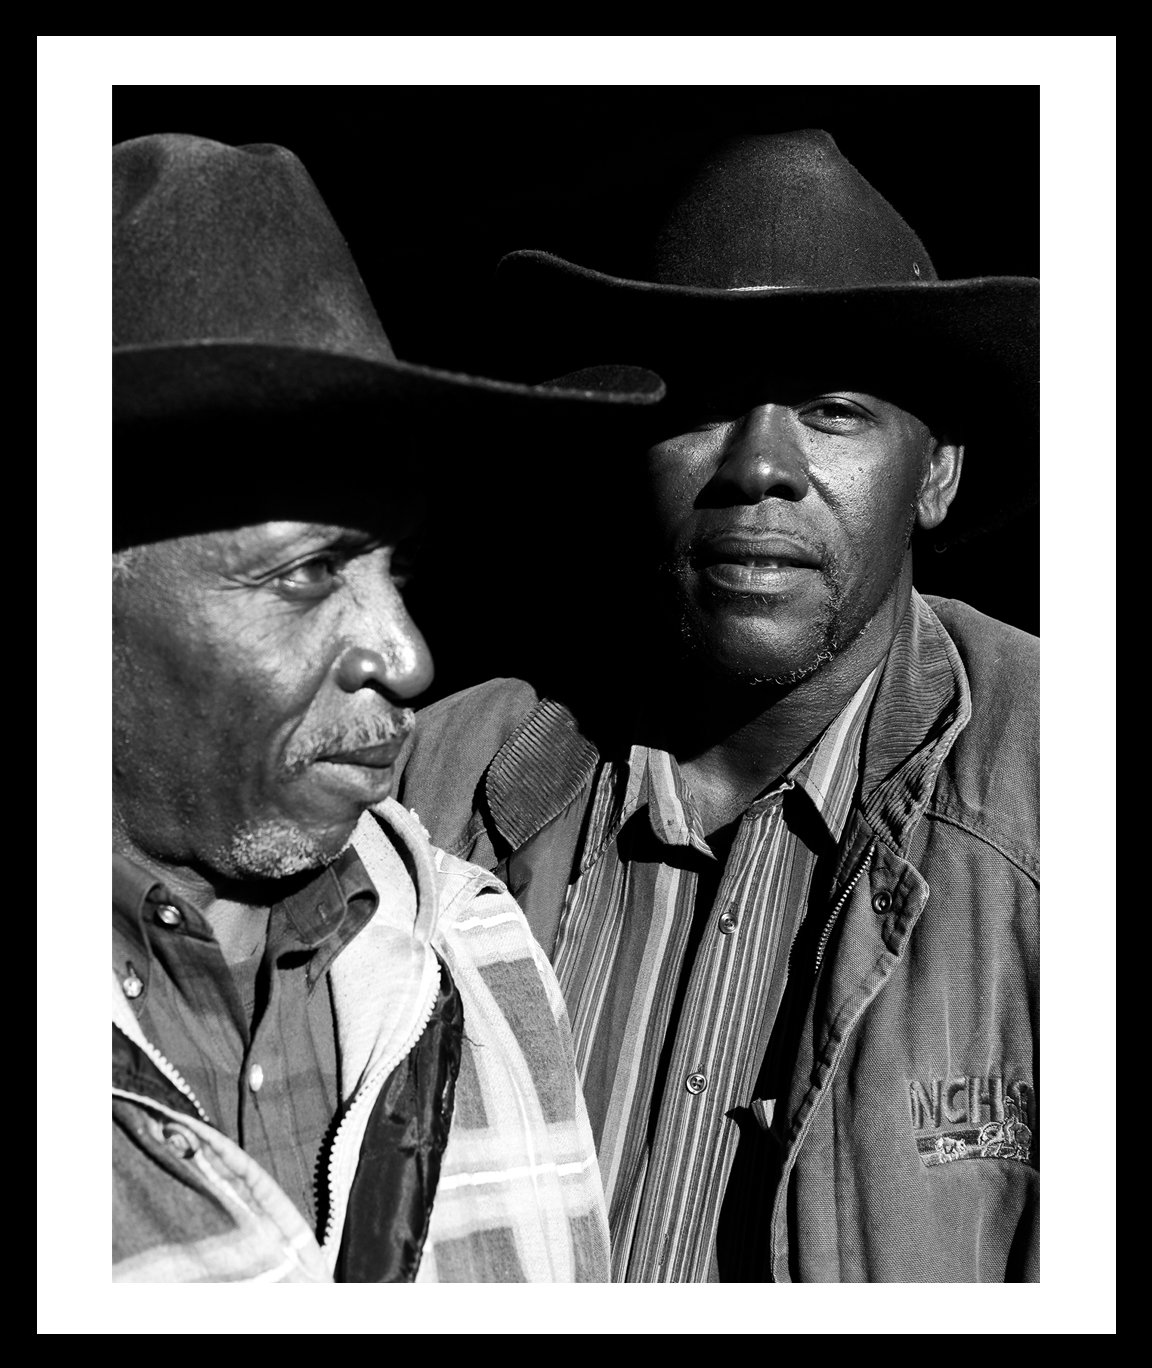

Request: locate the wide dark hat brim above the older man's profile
(112, 342), (664, 549)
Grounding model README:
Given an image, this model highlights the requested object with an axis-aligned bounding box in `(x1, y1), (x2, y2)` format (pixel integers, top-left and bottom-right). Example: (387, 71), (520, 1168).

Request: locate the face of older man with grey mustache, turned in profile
(112, 523), (432, 881)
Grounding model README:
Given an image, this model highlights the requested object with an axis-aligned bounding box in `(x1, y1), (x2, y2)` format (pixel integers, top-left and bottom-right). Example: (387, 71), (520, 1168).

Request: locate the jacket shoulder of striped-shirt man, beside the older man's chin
(394, 679), (539, 854)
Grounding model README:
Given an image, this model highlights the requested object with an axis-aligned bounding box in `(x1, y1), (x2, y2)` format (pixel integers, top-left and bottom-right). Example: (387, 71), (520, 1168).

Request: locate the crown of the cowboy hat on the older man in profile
(112, 134), (395, 361)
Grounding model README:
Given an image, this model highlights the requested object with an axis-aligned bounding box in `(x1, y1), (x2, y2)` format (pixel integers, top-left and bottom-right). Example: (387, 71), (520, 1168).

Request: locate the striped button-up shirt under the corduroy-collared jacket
(553, 669), (880, 1282)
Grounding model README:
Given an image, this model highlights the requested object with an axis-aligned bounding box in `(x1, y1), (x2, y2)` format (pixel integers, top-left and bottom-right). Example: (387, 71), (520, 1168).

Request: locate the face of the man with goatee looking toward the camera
(647, 384), (962, 684)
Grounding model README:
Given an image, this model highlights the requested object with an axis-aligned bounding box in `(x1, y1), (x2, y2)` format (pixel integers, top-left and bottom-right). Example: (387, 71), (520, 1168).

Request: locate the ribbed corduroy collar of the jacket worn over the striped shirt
(484, 590), (971, 851)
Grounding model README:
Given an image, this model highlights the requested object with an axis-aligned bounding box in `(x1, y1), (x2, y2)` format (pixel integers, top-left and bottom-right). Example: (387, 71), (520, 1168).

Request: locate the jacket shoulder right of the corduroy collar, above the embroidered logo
(928, 598), (1040, 877)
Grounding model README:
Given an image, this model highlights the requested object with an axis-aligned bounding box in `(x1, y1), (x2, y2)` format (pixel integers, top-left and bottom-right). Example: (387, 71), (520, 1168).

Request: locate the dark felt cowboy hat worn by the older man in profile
(112, 134), (664, 546)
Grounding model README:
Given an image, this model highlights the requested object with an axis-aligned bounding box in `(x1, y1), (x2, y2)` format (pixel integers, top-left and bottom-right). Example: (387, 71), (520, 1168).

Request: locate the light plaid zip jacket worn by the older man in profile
(112, 799), (609, 1282)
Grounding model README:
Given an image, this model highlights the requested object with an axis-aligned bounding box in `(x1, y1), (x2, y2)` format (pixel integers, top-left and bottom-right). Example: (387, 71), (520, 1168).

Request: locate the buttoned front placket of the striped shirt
(628, 793), (781, 1282)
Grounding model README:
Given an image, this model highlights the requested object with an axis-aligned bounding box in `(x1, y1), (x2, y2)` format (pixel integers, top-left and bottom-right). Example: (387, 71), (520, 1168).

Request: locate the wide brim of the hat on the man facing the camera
(498, 250), (1040, 547)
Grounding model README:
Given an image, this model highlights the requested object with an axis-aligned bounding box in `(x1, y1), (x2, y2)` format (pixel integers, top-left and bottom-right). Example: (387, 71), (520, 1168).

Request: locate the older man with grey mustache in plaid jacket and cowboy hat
(112, 135), (659, 1282)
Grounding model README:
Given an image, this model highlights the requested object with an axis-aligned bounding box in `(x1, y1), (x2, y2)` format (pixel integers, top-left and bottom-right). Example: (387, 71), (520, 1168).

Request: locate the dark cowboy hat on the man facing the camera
(498, 130), (1040, 544)
